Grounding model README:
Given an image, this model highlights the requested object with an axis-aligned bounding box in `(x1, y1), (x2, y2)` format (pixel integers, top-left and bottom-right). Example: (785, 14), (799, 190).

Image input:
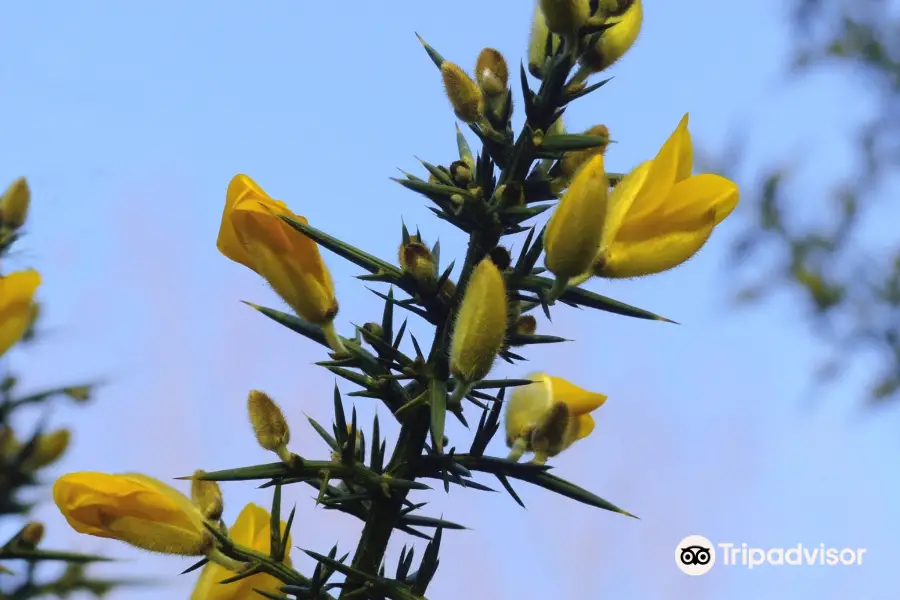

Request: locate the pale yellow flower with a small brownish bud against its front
(505, 373), (606, 463)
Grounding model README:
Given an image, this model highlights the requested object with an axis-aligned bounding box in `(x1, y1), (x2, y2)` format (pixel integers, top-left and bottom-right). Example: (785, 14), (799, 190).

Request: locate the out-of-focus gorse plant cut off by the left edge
(0, 177), (127, 600)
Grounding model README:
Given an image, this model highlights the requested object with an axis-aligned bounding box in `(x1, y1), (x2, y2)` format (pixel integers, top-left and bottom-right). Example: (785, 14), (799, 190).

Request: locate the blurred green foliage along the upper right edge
(718, 0), (900, 405)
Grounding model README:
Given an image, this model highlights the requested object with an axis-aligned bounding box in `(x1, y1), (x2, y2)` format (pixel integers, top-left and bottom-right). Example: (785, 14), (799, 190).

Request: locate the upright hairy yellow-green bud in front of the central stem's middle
(450, 258), (508, 383)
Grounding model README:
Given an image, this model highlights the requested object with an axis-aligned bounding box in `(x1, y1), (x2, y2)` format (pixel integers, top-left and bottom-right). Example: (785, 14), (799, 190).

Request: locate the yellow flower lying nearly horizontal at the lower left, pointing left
(53, 472), (213, 556)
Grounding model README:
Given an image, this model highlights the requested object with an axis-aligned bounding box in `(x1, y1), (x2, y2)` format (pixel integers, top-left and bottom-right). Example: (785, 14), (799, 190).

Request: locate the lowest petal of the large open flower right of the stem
(594, 213), (716, 278)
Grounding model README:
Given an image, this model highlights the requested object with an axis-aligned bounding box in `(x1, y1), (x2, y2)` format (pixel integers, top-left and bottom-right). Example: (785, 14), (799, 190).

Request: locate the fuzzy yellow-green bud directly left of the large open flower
(544, 154), (609, 282)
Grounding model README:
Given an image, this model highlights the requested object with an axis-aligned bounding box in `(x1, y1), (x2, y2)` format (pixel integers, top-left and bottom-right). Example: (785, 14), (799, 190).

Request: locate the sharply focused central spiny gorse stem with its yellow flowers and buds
(53, 0), (738, 600)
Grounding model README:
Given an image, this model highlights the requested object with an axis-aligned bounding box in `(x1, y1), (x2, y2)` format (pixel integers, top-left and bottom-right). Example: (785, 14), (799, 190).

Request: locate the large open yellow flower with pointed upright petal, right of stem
(581, 115), (739, 280)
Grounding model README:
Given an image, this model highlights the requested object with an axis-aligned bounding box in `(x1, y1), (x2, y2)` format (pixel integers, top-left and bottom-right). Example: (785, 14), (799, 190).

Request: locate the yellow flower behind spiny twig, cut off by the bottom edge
(191, 504), (291, 600)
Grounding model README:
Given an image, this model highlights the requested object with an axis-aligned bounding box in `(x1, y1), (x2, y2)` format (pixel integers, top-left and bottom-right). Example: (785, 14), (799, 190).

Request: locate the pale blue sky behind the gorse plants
(0, 0), (900, 600)
